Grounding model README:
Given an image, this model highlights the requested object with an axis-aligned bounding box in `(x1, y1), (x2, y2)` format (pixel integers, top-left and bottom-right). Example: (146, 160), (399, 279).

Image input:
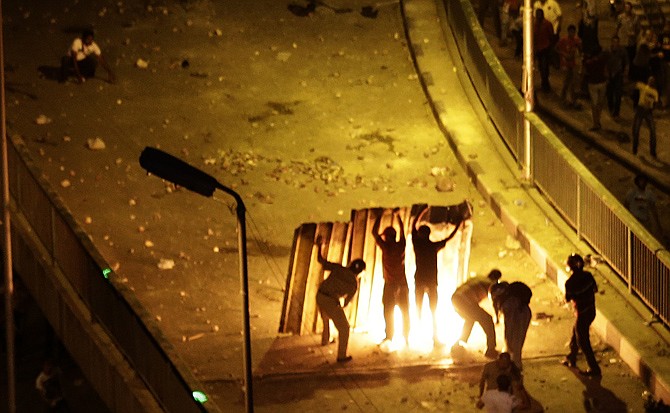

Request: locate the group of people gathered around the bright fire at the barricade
(315, 207), (601, 412)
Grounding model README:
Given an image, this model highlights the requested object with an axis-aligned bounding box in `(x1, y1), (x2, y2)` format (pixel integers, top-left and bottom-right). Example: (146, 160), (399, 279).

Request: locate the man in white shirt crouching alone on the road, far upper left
(59, 29), (115, 83)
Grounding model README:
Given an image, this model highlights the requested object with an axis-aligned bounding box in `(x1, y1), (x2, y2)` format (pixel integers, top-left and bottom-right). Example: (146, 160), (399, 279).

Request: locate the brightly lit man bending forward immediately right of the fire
(451, 270), (502, 359)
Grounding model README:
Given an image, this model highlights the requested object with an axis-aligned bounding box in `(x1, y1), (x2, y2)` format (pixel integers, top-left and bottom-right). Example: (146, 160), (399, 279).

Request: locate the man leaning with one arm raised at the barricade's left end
(316, 237), (365, 363)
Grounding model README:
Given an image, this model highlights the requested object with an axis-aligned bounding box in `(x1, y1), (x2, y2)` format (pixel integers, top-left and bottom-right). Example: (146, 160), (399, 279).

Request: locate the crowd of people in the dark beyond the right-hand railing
(477, 0), (670, 158)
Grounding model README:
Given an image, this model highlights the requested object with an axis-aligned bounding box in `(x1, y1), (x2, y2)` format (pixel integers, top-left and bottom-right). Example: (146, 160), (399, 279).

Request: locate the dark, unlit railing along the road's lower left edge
(8, 138), (218, 413)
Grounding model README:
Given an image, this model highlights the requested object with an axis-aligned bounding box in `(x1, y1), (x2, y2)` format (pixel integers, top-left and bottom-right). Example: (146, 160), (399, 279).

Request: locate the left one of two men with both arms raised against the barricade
(372, 208), (409, 345)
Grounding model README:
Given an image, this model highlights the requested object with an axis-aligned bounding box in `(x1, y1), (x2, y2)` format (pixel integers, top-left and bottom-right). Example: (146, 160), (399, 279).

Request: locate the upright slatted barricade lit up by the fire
(279, 201), (472, 335)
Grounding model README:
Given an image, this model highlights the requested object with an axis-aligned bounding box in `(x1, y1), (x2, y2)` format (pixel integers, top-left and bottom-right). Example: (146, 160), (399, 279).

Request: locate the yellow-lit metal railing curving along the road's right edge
(443, 0), (670, 328)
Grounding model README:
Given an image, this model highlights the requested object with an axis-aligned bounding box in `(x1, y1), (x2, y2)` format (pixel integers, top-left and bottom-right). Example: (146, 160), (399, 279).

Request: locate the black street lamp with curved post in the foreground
(140, 147), (254, 413)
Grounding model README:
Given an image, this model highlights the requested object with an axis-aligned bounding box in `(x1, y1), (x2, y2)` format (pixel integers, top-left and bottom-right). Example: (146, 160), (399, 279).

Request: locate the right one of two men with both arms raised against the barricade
(412, 205), (461, 343)
